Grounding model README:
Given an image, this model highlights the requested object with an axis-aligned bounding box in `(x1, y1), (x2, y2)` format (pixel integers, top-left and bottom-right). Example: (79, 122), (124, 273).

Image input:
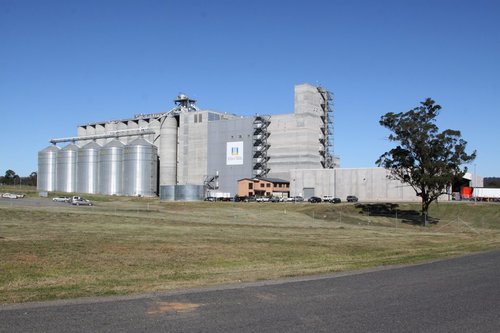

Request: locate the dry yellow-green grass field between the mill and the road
(0, 187), (500, 303)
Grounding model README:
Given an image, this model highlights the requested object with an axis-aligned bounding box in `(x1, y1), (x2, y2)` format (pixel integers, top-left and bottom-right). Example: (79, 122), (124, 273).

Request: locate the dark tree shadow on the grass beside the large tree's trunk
(355, 203), (439, 225)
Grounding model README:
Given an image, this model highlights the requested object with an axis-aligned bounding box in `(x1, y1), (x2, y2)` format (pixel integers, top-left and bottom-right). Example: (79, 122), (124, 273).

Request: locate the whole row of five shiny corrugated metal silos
(37, 138), (158, 196)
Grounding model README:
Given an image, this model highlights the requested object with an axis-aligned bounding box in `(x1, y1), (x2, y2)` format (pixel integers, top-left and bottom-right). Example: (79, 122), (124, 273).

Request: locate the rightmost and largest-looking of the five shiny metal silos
(123, 138), (158, 197)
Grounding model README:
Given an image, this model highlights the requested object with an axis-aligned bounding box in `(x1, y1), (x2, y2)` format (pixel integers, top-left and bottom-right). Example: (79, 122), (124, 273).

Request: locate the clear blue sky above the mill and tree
(0, 0), (500, 177)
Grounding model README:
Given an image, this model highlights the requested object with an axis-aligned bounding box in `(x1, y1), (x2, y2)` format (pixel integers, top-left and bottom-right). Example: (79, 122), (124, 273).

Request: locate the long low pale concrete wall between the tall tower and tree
(290, 168), (428, 201)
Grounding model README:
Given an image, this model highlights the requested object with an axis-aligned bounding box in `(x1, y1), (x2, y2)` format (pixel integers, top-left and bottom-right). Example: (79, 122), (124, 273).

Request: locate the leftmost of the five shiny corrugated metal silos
(36, 146), (59, 192)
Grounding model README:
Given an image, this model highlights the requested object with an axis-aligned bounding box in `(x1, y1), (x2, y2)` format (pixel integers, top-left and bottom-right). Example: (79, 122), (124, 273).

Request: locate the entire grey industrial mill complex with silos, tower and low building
(38, 84), (428, 201)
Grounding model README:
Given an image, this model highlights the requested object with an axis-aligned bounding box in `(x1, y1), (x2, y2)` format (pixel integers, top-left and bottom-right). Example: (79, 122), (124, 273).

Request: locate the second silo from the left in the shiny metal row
(56, 144), (80, 192)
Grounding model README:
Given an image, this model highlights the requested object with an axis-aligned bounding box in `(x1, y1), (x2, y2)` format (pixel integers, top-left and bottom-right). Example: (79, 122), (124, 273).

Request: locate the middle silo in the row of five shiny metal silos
(76, 142), (101, 194)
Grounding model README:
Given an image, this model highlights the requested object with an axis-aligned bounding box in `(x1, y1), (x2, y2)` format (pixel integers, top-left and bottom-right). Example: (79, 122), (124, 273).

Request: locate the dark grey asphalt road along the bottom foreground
(0, 250), (500, 333)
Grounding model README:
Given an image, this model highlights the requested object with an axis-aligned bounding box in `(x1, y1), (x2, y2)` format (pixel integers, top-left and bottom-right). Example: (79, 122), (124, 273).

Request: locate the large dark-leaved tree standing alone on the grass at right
(376, 98), (476, 225)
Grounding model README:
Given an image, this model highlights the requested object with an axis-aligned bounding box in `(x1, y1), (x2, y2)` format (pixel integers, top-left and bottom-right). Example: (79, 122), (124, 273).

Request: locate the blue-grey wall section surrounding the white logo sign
(208, 118), (253, 196)
